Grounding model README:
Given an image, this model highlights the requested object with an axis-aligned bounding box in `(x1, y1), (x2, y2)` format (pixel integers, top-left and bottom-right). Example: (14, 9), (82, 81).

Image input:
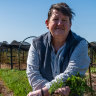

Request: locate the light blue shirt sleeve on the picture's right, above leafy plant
(46, 40), (90, 88)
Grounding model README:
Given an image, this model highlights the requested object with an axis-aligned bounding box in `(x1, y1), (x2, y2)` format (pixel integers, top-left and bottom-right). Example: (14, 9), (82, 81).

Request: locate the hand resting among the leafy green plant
(55, 86), (70, 96)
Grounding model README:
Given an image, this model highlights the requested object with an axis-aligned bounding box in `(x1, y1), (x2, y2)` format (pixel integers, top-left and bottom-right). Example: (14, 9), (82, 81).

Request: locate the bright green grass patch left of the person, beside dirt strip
(0, 69), (32, 96)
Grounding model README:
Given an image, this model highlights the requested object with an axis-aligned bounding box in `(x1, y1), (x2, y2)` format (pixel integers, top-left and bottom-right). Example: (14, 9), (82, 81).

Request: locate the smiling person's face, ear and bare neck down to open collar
(46, 9), (71, 51)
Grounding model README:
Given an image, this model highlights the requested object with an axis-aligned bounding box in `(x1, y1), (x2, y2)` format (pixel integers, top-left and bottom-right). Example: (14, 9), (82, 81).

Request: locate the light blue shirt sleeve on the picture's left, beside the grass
(26, 41), (48, 90)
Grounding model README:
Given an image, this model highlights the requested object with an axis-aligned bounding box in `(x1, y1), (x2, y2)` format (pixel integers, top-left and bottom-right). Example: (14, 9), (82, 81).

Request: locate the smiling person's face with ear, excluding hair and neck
(46, 9), (71, 38)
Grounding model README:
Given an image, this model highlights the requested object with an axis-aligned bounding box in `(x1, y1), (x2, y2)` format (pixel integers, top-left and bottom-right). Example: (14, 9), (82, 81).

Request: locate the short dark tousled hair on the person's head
(48, 3), (75, 22)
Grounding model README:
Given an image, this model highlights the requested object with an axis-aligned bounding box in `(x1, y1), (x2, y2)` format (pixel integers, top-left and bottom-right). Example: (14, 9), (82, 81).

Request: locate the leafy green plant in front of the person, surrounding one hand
(49, 74), (93, 96)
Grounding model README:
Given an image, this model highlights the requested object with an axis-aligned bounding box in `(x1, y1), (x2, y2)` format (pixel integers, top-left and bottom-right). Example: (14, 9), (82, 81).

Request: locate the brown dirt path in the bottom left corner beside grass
(0, 78), (13, 96)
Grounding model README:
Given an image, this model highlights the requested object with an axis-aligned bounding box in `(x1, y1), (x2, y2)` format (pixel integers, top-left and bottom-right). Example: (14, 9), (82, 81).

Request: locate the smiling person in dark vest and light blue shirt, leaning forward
(26, 3), (90, 96)
